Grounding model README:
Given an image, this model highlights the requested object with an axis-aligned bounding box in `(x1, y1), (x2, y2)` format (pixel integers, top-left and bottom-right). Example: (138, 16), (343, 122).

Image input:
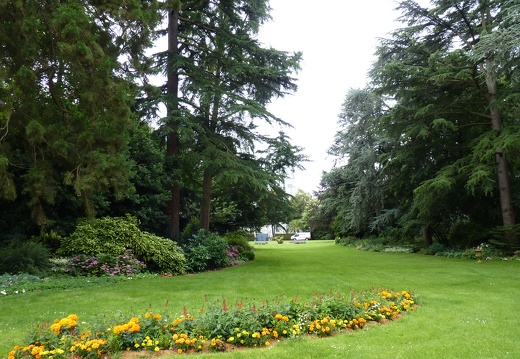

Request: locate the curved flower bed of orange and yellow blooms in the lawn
(8, 290), (416, 359)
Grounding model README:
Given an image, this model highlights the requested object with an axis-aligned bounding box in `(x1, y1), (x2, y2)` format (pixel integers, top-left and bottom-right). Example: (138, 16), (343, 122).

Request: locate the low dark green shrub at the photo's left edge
(0, 241), (51, 275)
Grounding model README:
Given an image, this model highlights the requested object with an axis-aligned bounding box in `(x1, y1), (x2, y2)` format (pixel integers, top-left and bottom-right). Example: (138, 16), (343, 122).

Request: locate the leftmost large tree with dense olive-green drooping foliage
(0, 0), (159, 231)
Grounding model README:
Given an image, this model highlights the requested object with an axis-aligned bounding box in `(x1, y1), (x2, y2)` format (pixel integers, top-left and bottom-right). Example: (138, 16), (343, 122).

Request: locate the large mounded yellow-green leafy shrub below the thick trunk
(59, 216), (186, 274)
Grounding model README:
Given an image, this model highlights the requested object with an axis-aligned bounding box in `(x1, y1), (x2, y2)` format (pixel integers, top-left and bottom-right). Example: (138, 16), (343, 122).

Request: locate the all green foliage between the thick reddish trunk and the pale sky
(160, 1), (304, 233)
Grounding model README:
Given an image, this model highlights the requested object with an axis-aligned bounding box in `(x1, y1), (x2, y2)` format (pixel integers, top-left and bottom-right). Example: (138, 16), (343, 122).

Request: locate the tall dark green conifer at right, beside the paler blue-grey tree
(371, 0), (520, 248)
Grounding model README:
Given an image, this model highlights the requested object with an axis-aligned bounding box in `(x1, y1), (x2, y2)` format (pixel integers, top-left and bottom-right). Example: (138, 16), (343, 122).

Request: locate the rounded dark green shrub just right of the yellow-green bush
(182, 229), (231, 272)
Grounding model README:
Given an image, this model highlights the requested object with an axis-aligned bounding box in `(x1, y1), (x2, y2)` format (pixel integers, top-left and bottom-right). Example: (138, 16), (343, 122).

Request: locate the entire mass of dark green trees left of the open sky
(0, 0), (305, 243)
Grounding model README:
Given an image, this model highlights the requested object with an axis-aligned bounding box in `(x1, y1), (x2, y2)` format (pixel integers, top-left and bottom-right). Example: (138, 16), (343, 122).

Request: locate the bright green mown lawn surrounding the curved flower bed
(0, 241), (520, 359)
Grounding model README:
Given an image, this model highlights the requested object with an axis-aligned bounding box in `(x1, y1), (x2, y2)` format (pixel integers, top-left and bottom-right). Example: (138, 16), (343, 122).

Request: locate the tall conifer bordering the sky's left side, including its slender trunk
(157, 0), (301, 233)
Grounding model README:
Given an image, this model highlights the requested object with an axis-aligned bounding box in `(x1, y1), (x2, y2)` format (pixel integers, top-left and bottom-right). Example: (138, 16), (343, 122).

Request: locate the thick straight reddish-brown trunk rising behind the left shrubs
(166, 3), (181, 239)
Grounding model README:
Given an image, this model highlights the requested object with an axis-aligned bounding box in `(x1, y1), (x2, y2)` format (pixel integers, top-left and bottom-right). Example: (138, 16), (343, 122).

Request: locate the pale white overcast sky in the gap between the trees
(259, 0), (399, 194)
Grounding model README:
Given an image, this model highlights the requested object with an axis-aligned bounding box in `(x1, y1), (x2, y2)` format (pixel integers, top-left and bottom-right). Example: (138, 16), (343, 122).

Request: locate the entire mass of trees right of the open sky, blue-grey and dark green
(314, 0), (520, 252)
